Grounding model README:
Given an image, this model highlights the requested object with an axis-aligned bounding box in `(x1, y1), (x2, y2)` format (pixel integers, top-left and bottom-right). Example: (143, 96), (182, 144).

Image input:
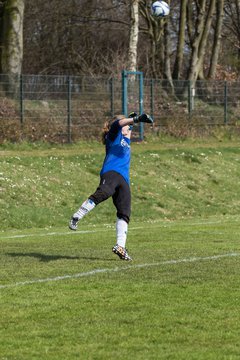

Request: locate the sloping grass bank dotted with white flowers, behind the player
(0, 142), (240, 230)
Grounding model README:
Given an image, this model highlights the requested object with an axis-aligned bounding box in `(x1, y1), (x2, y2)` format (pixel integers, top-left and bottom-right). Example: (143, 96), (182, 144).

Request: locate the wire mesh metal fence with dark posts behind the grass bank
(0, 74), (240, 142)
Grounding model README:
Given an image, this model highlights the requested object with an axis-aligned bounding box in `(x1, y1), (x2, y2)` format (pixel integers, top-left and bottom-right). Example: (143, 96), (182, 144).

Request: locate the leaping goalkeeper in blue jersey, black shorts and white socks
(69, 113), (153, 260)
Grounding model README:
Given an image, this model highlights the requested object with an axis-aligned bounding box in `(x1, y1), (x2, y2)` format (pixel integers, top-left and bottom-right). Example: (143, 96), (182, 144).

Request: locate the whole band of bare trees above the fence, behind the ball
(0, 0), (240, 81)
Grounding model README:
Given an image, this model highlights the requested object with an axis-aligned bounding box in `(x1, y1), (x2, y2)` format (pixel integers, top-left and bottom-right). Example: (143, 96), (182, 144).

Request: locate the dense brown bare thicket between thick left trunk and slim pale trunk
(23, 0), (130, 76)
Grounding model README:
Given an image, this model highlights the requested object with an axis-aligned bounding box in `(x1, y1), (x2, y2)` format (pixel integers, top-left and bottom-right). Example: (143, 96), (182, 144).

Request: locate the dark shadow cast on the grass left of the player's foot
(6, 252), (115, 262)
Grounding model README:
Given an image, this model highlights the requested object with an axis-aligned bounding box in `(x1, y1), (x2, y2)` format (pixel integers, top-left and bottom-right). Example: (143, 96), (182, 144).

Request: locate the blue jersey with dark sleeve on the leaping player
(100, 120), (131, 184)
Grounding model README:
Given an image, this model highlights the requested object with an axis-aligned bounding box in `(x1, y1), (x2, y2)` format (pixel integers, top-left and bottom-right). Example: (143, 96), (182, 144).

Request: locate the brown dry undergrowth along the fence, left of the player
(0, 99), (109, 143)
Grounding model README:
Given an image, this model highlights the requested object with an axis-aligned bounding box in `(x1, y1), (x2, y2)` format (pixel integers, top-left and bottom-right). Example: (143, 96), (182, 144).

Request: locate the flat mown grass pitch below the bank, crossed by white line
(0, 217), (240, 360)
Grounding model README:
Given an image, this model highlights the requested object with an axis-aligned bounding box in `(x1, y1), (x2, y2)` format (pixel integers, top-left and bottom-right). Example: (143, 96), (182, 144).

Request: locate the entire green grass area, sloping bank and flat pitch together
(0, 142), (240, 360)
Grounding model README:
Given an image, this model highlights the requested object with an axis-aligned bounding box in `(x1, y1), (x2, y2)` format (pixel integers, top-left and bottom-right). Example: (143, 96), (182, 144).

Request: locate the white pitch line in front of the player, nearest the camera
(0, 253), (240, 290)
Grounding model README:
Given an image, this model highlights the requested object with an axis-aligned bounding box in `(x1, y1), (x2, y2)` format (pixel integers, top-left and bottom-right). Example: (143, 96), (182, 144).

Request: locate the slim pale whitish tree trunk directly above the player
(128, 0), (139, 71)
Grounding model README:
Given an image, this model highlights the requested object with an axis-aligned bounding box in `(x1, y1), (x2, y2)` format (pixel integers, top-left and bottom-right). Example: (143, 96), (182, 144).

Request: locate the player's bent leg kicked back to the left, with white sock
(69, 171), (117, 230)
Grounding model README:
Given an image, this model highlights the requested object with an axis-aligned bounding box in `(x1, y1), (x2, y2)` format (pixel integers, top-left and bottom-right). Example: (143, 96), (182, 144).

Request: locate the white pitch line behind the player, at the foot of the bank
(0, 220), (227, 241)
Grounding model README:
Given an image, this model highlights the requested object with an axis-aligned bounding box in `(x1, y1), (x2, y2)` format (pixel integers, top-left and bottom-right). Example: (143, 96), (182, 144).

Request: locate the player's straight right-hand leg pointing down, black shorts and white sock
(112, 179), (132, 260)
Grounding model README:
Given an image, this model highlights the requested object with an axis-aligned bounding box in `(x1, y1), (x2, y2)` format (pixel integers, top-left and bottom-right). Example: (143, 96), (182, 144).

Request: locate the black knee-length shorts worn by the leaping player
(89, 171), (131, 223)
